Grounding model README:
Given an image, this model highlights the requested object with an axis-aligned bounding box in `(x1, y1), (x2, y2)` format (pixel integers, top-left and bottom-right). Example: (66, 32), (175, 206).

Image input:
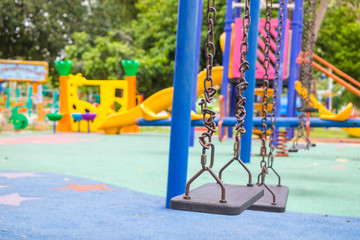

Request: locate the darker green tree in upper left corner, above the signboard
(0, 0), (87, 84)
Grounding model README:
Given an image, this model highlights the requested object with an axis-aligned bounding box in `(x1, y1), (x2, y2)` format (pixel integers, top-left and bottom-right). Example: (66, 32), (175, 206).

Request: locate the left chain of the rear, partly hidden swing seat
(260, 0), (272, 184)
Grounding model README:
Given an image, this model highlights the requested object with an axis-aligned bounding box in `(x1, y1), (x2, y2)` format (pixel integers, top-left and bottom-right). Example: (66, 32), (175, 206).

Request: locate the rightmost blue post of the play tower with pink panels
(286, 0), (303, 138)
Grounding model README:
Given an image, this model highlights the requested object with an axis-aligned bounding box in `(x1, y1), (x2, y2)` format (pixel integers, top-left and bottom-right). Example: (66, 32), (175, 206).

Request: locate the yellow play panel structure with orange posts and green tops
(55, 60), (139, 133)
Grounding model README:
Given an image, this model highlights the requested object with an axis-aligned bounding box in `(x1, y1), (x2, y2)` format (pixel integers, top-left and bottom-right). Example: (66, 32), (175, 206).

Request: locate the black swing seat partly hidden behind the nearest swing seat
(249, 185), (289, 212)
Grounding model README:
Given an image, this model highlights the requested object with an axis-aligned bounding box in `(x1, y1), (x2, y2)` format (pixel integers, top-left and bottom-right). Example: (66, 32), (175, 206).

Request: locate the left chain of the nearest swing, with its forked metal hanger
(183, 0), (226, 203)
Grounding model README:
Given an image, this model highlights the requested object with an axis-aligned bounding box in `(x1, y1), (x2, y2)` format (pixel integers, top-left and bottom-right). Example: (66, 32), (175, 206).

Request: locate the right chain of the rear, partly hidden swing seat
(268, 0), (286, 167)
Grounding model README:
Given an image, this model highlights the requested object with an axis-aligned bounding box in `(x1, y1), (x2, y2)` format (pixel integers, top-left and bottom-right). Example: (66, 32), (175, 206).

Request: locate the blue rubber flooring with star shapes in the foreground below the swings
(0, 171), (360, 240)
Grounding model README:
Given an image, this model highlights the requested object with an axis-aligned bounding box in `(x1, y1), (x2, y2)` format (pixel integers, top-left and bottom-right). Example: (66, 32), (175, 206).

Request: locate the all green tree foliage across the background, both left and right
(0, 0), (360, 105)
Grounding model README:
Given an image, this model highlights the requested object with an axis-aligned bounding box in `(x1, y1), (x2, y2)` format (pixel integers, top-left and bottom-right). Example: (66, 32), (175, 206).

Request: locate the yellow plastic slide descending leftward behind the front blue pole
(99, 66), (223, 134)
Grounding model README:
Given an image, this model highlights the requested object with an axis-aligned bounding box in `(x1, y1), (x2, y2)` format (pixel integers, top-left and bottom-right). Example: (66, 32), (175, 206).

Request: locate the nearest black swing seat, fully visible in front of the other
(170, 183), (264, 215)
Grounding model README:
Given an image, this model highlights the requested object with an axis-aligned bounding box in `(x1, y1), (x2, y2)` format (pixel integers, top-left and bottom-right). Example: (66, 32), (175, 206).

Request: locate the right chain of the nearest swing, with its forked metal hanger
(219, 0), (252, 186)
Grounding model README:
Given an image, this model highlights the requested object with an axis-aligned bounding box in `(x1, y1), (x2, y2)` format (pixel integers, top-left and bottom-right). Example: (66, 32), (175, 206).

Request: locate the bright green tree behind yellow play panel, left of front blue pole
(66, 0), (225, 97)
